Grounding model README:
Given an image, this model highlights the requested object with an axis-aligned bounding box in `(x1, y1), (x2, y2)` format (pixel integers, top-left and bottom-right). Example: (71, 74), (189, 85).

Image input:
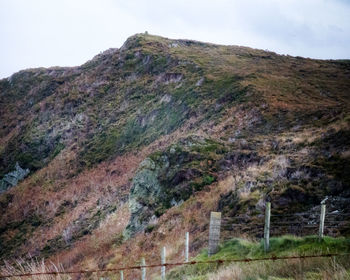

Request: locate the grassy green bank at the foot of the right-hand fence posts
(167, 236), (350, 280)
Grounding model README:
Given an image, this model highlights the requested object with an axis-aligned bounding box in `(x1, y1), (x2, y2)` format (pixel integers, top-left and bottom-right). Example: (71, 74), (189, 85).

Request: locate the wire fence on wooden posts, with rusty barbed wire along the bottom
(0, 205), (350, 279)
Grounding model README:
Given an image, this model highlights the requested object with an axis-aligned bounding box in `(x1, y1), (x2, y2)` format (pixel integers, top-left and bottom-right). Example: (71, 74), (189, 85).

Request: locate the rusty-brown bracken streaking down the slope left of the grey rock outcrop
(1, 111), (205, 268)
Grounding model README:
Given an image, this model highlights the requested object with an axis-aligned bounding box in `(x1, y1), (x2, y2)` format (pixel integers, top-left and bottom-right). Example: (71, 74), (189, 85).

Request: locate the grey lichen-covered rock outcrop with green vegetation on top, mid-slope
(124, 136), (260, 238)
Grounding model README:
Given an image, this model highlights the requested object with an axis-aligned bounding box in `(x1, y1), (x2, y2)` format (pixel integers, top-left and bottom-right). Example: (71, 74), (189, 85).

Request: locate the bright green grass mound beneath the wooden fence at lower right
(167, 236), (350, 280)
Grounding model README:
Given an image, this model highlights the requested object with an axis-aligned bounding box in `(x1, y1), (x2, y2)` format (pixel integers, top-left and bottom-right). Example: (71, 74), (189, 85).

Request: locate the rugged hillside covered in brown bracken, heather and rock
(0, 34), (350, 278)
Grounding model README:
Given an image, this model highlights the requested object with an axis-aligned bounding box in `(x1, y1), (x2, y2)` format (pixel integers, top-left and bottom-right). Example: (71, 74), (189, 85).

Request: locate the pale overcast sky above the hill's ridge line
(0, 0), (350, 78)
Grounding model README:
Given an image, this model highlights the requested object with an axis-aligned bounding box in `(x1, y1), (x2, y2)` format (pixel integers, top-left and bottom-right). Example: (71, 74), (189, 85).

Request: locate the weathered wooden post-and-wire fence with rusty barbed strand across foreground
(0, 202), (350, 280)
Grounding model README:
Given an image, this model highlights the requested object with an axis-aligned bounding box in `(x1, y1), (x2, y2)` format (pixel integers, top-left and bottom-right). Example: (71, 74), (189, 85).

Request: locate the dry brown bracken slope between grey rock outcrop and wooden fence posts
(108, 177), (227, 279)
